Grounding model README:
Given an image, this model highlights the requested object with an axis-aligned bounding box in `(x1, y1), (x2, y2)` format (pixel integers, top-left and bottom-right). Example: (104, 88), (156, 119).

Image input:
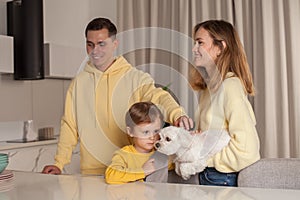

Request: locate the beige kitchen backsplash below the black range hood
(0, 74), (70, 141)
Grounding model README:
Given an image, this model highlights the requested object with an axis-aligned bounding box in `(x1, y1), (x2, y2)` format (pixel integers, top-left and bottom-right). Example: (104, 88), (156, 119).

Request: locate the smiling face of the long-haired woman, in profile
(192, 28), (221, 71)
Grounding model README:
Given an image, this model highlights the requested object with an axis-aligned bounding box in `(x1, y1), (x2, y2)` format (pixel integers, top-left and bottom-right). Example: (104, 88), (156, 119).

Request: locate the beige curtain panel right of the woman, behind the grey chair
(235, 0), (300, 157)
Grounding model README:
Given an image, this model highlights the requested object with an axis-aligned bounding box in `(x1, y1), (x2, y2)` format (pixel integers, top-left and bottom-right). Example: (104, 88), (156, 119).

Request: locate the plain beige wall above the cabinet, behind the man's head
(44, 0), (116, 47)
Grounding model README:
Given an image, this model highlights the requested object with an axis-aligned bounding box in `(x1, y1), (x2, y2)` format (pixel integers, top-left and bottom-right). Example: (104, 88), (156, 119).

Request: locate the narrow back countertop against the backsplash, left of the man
(0, 138), (58, 151)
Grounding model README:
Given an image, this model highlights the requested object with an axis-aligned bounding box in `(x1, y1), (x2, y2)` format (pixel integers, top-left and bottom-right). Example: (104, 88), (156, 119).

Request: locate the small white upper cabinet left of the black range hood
(0, 35), (14, 73)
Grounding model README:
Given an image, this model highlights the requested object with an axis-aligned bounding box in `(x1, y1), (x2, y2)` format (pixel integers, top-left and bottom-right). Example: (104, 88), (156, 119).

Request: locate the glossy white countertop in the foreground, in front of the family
(0, 171), (300, 200)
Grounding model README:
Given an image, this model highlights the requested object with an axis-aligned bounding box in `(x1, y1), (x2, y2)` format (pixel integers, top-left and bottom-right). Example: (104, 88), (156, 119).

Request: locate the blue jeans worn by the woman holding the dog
(199, 167), (238, 187)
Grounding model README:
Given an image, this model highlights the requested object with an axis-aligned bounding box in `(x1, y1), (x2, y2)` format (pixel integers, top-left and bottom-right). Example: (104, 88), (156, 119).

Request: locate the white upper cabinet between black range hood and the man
(44, 43), (87, 78)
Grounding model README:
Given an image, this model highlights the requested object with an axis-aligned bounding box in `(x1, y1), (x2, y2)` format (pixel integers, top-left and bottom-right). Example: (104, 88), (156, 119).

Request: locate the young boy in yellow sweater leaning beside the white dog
(105, 102), (167, 184)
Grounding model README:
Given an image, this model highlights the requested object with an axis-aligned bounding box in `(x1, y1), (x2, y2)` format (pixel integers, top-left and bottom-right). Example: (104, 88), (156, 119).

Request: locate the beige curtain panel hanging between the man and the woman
(117, 0), (233, 120)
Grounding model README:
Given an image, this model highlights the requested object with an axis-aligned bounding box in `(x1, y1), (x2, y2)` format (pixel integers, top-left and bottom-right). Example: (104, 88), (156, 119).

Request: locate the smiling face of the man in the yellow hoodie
(86, 29), (118, 71)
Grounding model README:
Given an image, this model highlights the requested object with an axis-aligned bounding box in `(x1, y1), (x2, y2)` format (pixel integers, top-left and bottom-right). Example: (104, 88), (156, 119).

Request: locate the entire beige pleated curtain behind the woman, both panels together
(117, 0), (300, 157)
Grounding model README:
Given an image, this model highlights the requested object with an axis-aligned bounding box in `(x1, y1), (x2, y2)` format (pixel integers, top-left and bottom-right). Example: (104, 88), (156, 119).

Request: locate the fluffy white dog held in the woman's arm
(155, 126), (230, 180)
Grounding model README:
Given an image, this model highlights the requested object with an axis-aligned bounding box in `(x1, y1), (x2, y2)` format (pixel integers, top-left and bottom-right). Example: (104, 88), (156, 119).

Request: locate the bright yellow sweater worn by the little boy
(105, 145), (154, 184)
